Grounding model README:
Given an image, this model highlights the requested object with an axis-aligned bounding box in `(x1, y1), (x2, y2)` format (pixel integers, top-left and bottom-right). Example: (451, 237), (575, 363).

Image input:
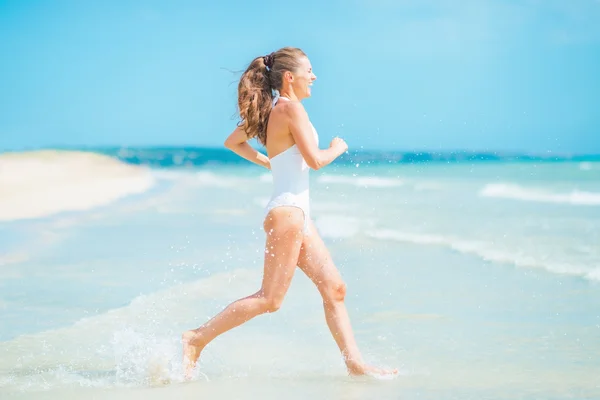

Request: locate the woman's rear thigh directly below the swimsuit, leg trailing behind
(261, 207), (304, 298)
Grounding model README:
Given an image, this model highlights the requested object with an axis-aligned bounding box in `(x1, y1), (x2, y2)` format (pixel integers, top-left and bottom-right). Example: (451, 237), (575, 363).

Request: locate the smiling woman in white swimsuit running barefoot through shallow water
(182, 47), (397, 377)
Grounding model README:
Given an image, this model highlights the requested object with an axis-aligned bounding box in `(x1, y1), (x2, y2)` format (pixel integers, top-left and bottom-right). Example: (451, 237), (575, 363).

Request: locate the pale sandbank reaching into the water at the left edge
(0, 150), (155, 221)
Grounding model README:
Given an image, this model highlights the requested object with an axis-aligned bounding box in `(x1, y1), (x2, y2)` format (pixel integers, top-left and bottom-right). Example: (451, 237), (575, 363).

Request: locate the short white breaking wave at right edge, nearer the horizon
(479, 183), (600, 206)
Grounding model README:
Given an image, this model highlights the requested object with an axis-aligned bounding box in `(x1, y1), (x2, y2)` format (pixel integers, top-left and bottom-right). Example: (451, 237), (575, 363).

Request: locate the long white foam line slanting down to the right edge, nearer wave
(367, 229), (600, 281)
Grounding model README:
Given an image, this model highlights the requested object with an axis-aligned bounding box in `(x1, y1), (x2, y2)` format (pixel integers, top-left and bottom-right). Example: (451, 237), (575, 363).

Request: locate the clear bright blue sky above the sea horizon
(0, 0), (600, 153)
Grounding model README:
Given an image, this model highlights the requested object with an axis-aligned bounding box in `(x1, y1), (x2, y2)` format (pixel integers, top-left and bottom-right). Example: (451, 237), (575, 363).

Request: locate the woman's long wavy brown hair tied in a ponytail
(238, 47), (306, 146)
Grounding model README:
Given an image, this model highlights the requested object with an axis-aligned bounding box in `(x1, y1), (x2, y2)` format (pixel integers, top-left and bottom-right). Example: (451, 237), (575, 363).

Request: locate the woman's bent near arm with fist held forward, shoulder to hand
(287, 102), (348, 170)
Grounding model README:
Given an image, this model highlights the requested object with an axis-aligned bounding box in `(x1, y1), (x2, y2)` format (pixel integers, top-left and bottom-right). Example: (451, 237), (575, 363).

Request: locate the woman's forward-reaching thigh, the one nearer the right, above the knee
(298, 220), (343, 294)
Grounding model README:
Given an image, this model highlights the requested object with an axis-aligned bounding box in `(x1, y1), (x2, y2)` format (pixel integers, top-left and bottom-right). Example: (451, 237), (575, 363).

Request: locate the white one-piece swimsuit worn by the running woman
(264, 96), (319, 234)
